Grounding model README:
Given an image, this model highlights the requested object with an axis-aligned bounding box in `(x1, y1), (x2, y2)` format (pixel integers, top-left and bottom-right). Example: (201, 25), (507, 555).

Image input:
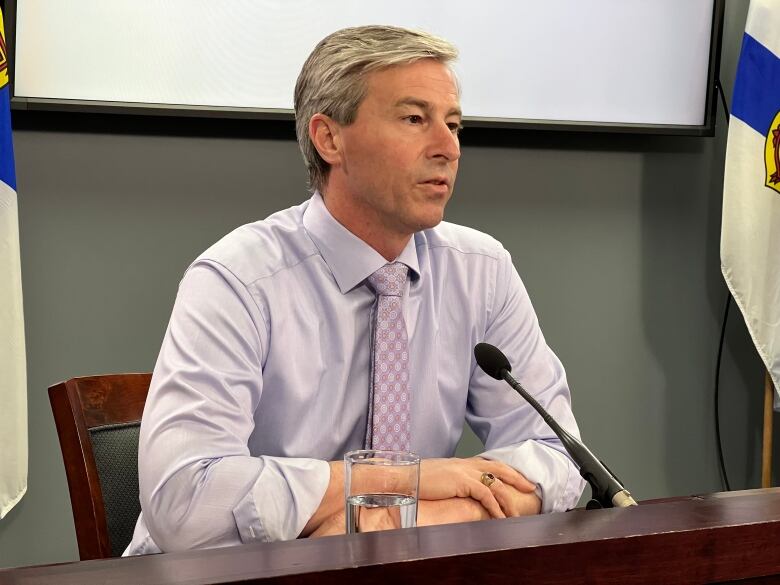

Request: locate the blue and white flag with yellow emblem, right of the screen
(720, 0), (780, 408)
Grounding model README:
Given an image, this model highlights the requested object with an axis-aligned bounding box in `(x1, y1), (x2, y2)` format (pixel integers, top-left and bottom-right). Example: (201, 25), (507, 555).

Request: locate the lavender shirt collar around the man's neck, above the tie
(303, 192), (420, 294)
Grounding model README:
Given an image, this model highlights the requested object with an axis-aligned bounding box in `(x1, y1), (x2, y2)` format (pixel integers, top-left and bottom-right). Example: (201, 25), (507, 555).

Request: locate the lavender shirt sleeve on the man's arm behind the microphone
(466, 249), (584, 512)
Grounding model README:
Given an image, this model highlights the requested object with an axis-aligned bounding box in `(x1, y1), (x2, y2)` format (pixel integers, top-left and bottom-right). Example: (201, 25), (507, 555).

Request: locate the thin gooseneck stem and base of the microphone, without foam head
(500, 368), (637, 508)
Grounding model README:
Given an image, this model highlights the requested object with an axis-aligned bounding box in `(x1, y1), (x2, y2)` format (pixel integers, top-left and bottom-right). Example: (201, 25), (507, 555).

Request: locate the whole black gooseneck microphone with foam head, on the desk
(474, 343), (637, 508)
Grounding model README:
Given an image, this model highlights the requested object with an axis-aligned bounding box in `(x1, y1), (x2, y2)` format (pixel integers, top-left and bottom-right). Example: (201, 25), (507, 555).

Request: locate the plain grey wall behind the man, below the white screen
(0, 0), (762, 567)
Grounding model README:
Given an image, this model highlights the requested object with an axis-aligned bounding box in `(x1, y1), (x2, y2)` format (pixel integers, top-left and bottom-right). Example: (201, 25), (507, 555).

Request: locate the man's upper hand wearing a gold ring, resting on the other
(419, 457), (541, 518)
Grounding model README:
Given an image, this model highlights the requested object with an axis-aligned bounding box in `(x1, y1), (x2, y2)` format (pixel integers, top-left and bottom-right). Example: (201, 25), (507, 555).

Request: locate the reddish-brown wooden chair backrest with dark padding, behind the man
(49, 374), (152, 560)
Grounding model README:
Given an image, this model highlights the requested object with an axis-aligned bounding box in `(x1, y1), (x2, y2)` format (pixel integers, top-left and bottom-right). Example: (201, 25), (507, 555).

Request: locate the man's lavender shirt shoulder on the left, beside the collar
(193, 202), (317, 284)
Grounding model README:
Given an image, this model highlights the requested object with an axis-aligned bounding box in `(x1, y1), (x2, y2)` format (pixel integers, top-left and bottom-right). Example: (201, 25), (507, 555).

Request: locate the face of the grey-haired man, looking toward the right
(332, 59), (461, 235)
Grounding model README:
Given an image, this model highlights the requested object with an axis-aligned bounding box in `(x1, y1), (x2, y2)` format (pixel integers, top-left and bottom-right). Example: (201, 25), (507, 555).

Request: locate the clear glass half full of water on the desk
(344, 449), (420, 534)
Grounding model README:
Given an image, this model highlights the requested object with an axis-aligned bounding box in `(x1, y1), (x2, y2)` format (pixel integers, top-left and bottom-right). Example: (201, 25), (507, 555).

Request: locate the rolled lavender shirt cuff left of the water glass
(233, 457), (330, 543)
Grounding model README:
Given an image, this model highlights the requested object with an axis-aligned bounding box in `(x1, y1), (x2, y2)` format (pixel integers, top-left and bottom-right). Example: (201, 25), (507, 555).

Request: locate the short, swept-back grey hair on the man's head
(294, 25), (458, 191)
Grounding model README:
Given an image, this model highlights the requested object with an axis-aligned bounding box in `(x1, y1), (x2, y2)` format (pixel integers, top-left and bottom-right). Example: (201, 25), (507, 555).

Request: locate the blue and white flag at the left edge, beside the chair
(0, 6), (27, 518)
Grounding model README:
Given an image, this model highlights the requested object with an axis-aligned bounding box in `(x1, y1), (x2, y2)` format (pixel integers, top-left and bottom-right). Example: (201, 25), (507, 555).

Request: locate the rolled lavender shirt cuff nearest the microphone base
(477, 441), (585, 513)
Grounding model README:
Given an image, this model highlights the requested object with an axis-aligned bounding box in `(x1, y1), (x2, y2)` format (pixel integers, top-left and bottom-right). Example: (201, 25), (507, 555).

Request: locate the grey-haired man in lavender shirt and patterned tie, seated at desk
(127, 26), (583, 554)
